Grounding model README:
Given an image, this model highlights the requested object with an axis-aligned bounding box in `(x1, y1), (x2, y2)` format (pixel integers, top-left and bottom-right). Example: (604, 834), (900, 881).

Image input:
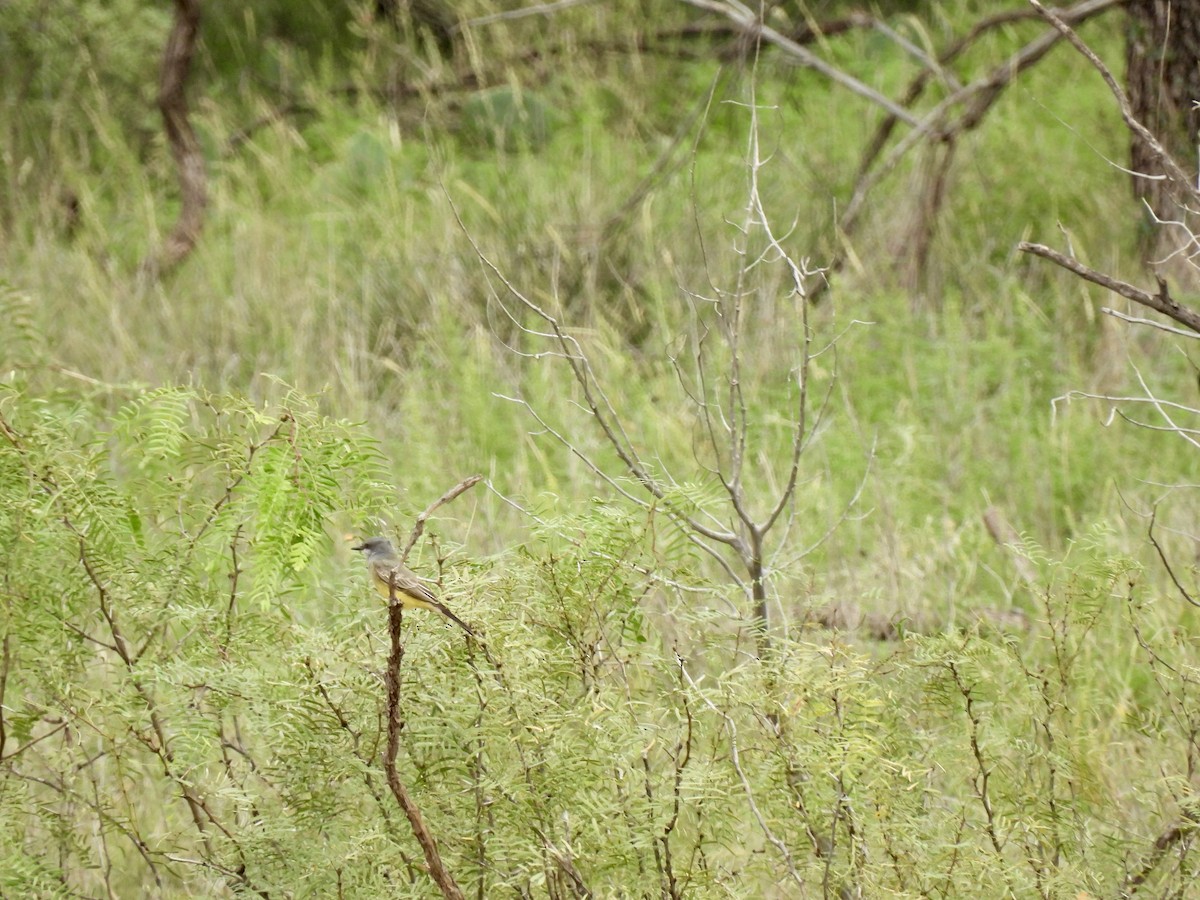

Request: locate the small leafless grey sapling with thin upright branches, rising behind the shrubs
(451, 93), (862, 654)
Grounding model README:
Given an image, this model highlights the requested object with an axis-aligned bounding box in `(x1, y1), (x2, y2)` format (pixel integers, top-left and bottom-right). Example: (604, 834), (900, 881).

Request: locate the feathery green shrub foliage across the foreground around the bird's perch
(0, 383), (1200, 896)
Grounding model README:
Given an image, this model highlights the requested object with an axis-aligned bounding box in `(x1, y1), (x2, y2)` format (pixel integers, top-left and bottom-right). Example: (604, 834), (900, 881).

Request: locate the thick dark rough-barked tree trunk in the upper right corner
(1126, 0), (1200, 256)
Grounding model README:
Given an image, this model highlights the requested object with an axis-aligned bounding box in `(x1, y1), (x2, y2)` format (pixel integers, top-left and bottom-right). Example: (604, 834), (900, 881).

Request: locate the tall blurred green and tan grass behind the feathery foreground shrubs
(4, 8), (1186, 606)
